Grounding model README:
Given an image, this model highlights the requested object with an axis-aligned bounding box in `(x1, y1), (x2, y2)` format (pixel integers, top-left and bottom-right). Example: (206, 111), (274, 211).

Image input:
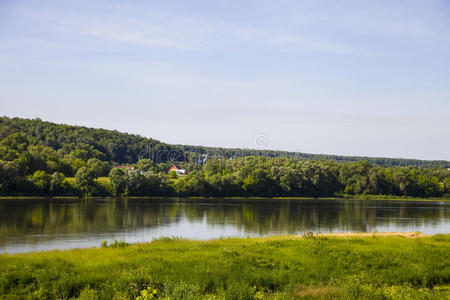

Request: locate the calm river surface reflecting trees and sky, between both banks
(0, 198), (450, 252)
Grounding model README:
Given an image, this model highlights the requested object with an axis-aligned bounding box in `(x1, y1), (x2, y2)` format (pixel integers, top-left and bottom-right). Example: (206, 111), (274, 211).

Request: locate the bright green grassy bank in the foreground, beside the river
(0, 234), (450, 299)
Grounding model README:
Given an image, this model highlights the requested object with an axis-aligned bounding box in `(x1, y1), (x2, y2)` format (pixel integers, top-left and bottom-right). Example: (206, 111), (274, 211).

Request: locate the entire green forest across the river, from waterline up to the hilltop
(0, 117), (450, 197)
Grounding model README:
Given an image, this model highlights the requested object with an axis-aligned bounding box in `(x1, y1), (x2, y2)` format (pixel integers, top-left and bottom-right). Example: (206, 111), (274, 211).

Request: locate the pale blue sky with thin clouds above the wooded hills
(0, 0), (450, 160)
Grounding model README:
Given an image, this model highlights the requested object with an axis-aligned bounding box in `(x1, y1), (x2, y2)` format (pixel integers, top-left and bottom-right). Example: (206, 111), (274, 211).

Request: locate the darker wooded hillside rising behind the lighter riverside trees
(0, 117), (450, 168)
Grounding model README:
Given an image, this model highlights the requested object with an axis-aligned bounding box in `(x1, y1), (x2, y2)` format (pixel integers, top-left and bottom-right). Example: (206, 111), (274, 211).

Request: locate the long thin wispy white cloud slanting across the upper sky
(11, 4), (368, 54)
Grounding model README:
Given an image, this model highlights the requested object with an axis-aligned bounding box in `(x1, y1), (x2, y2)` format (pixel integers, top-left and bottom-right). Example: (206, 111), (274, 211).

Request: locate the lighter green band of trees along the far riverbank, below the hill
(0, 157), (450, 197)
